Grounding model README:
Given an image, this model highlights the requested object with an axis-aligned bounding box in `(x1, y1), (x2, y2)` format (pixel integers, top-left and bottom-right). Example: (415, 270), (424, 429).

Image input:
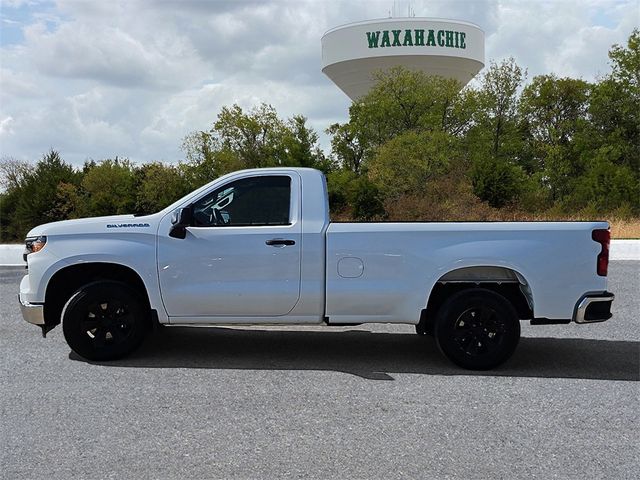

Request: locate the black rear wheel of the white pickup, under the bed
(434, 288), (520, 370)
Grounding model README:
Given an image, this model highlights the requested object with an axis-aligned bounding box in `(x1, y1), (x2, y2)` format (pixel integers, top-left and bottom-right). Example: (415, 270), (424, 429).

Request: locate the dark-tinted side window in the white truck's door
(193, 176), (291, 227)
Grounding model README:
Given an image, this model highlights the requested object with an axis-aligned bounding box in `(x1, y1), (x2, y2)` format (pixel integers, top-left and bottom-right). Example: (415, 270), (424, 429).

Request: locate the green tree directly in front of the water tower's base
(327, 67), (477, 220)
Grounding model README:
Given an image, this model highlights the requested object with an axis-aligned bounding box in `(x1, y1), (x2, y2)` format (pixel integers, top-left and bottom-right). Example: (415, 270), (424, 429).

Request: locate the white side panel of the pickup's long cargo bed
(326, 222), (608, 323)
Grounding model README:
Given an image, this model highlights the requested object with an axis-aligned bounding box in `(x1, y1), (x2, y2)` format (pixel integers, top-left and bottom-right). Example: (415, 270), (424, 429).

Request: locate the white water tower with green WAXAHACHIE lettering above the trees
(322, 17), (484, 100)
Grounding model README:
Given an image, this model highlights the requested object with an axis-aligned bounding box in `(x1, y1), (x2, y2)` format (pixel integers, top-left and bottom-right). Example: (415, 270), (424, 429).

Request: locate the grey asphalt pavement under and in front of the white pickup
(0, 262), (640, 480)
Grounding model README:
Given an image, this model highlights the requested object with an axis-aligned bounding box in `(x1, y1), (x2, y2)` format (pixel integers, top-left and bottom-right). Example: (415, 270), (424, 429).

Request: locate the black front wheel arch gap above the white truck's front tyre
(44, 262), (151, 330)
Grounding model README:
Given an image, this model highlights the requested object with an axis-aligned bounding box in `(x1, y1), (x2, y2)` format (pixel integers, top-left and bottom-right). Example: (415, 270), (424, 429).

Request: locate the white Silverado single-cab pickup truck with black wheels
(19, 168), (614, 369)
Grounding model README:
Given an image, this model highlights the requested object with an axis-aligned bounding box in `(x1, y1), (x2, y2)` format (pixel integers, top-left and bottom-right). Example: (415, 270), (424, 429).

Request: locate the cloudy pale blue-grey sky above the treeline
(0, 0), (640, 166)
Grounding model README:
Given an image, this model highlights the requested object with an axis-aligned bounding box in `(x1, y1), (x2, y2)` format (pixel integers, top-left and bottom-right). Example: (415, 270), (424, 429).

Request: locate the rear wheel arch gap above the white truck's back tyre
(420, 265), (534, 330)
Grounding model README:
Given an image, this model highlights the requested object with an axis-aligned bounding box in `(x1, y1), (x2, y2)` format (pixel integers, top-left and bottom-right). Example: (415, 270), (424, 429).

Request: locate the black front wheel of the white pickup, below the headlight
(62, 281), (150, 360)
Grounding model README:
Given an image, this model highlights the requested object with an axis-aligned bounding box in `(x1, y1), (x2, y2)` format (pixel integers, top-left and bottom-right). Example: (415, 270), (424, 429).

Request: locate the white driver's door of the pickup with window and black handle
(158, 172), (302, 321)
